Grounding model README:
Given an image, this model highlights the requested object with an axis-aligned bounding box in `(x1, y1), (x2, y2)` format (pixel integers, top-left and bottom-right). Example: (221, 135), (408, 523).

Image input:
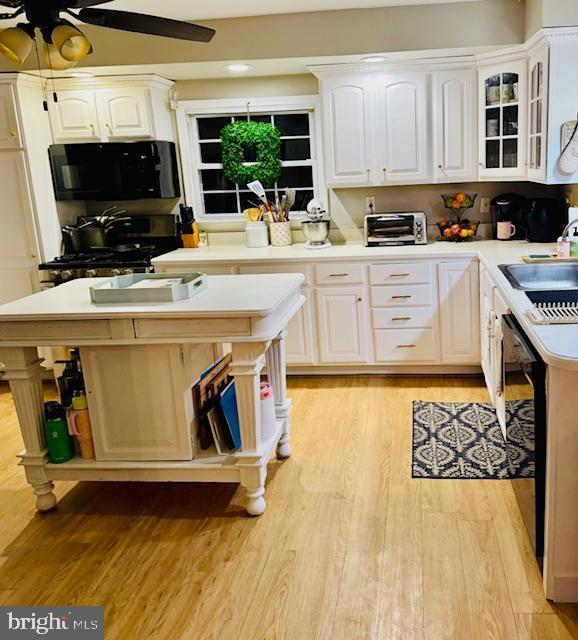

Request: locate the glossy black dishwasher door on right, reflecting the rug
(502, 315), (546, 566)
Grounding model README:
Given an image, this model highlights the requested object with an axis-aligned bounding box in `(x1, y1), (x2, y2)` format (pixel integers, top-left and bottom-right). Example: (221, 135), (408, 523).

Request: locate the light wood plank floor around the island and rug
(0, 378), (578, 640)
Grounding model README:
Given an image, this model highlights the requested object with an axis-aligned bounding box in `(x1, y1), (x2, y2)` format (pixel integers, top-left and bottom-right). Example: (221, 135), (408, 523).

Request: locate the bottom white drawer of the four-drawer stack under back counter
(374, 329), (438, 362)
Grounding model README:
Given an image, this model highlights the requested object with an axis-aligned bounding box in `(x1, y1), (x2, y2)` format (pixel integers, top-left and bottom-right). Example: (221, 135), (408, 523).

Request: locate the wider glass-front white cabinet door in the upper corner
(479, 60), (527, 179)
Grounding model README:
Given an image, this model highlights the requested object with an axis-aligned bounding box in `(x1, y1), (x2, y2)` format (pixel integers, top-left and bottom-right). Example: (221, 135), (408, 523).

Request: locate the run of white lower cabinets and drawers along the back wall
(160, 258), (487, 373)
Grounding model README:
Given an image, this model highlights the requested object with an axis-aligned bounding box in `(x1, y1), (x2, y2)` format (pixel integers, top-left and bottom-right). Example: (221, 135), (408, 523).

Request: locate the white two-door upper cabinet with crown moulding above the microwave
(48, 76), (174, 142)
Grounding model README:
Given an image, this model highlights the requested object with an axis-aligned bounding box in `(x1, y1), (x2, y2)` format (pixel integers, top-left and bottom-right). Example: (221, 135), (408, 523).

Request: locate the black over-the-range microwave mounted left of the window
(48, 140), (181, 200)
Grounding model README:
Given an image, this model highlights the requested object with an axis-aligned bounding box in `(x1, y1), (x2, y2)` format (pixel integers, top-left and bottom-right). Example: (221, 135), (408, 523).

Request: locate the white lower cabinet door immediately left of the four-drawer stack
(315, 287), (368, 364)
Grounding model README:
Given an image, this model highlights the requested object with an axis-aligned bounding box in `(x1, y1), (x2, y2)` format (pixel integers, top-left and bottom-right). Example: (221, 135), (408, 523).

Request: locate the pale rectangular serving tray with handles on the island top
(90, 273), (207, 304)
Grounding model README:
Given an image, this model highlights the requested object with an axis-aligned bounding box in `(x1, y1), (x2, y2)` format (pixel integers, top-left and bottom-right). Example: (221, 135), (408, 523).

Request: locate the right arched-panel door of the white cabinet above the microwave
(98, 89), (154, 139)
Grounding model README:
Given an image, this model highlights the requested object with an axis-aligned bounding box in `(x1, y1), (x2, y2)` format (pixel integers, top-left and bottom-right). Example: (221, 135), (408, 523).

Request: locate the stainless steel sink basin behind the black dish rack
(499, 263), (578, 291)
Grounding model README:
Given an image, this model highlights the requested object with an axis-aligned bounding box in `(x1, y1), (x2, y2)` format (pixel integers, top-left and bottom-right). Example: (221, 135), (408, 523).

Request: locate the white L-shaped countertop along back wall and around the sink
(153, 240), (578, 370)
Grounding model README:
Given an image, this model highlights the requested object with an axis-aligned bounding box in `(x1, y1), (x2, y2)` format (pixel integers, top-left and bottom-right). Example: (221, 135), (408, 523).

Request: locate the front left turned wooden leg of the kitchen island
(0, 347), (56, 511)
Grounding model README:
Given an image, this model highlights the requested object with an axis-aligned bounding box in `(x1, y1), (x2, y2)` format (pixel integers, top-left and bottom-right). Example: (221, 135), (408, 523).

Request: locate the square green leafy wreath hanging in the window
(221, 120), (282, 187)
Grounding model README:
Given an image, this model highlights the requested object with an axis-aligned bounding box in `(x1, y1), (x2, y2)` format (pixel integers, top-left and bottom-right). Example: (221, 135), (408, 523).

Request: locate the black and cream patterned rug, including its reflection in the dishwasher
(412, 400), (534, 480)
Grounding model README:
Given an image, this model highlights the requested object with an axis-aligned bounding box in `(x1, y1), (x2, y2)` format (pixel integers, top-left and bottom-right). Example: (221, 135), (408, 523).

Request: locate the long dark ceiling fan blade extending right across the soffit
(78, 9), (215, 42)
